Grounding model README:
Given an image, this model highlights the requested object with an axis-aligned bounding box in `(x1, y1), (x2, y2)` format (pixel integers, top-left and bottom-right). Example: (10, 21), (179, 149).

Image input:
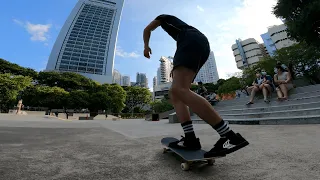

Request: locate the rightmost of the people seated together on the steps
(274, 65), (293, 100)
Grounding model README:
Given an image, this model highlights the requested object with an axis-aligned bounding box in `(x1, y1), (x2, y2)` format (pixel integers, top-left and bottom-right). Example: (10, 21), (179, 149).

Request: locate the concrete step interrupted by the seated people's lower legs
(216, 89), (320, 107)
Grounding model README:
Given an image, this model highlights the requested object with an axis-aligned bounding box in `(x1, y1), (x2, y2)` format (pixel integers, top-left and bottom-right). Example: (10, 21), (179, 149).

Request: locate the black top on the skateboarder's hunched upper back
(155, 14), (197, 41)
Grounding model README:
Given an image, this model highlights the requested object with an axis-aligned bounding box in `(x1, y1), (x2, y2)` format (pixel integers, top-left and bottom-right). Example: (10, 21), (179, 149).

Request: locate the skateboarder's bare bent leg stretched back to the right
(170, 67), (222, 126)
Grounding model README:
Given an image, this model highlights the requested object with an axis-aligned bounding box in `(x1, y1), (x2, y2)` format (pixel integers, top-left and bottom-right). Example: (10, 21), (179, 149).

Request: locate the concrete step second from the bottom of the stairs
(221, 107), (320, 119)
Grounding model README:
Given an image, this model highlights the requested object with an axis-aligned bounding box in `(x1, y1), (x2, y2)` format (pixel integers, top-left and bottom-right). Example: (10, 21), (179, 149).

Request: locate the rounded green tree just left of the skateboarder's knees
(125, 86), (152, 112)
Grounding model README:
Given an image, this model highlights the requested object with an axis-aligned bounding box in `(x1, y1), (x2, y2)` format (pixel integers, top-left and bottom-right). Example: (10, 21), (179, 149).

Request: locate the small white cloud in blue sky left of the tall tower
(13, 19), (52, 44)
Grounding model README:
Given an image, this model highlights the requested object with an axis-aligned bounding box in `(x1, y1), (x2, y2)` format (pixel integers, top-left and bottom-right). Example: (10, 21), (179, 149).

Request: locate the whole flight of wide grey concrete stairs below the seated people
(171, 85), (320, 125)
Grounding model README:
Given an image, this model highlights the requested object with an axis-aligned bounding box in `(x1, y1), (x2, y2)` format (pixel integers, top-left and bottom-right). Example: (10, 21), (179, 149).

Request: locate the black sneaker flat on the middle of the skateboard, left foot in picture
(169, 136), (201, 150)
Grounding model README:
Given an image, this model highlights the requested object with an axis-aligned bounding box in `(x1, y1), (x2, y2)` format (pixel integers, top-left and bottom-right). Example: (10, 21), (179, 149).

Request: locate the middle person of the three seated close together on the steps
(259, 70), (274, 103)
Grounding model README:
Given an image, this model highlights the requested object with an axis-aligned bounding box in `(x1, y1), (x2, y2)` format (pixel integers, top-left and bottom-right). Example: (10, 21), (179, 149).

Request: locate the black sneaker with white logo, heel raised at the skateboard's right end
(204, 133), (249, 158)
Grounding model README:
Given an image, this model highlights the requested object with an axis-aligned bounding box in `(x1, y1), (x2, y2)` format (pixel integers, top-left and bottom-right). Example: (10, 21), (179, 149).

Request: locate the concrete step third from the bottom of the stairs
(218, 101), (320, 114)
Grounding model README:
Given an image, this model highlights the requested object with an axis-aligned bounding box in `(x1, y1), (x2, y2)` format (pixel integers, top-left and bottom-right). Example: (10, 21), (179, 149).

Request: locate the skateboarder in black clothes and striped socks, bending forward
(143, 14), (249, 158)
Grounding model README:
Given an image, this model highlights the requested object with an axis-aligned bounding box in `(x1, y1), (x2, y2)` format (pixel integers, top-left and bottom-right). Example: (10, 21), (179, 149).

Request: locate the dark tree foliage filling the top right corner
(273, 0), (320, 47)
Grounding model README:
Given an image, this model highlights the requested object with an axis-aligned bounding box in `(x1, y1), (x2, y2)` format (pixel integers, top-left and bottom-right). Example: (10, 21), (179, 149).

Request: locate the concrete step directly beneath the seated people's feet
(214, 95), (320, 111)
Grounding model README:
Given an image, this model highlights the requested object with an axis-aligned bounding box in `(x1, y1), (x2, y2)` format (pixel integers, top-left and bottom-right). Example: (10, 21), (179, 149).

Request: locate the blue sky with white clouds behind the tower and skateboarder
(0, 0), (282, 90)
